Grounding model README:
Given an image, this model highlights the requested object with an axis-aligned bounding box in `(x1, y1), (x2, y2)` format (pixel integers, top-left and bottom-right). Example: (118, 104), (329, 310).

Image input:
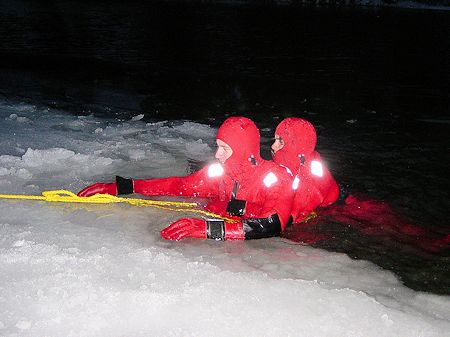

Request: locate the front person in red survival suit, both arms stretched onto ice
(78, 117), (294, 240)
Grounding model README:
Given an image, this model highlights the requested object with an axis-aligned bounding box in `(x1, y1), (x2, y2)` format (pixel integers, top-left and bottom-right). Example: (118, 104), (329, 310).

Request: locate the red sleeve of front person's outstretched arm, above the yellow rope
(133, 166), (218, 198)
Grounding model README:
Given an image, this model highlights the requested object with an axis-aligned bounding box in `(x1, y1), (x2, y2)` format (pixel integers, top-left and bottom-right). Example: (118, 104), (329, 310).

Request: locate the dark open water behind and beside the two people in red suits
(0, 1), (450, 294)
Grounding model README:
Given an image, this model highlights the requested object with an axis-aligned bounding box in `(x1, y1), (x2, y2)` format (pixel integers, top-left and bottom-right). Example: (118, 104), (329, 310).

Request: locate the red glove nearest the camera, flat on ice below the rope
(161, 218), (206, 241)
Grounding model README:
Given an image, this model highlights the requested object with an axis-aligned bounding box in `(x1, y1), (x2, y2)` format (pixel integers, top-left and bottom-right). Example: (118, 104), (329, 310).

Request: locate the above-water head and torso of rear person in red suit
(272, 118), (339, 223)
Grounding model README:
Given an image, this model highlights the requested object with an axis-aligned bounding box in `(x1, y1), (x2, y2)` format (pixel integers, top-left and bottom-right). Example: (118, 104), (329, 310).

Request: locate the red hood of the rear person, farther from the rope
(273, 117), (317, 174)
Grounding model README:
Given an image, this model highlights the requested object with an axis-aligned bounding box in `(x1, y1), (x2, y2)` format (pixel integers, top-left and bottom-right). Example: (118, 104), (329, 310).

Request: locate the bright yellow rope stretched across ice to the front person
(0, 190), (237, 222)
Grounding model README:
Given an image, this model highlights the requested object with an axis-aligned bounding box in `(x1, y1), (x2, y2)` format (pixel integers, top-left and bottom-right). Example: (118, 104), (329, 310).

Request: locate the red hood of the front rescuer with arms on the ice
(216, 117), (261, 178)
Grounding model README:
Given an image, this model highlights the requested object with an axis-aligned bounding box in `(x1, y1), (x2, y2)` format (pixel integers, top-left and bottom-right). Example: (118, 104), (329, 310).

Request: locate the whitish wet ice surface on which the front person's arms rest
(0, 102), (450, 336)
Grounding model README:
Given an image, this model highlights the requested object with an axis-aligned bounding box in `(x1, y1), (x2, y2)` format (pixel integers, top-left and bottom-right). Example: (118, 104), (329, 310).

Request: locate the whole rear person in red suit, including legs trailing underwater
(272, 118), (450, 252)
